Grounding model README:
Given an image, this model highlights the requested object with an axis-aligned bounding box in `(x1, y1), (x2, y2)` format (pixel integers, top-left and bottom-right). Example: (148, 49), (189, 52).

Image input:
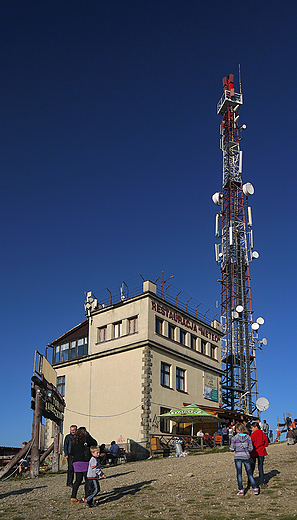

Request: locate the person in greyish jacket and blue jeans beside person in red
(230, 423), (259, 496)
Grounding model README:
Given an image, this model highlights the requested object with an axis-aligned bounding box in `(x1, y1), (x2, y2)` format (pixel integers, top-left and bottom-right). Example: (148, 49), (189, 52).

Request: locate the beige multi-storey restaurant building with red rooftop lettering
(47, 281), (222, 458)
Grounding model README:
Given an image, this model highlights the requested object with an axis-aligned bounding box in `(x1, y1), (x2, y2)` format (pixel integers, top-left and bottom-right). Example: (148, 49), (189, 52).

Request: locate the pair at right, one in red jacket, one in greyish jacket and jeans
(230, 421), (268, 496)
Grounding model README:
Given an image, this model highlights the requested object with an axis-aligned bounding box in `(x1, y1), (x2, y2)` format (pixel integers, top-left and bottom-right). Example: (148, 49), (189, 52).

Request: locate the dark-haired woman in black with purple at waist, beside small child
(70, 426), (97, 504)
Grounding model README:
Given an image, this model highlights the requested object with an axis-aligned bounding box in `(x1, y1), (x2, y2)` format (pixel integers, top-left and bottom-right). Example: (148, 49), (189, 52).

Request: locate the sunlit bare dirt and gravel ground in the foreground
(0, 443), (297, 520)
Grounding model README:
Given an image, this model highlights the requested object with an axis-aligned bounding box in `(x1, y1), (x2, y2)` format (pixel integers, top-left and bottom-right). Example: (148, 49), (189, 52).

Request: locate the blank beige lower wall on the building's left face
(57, 348), (142, 444)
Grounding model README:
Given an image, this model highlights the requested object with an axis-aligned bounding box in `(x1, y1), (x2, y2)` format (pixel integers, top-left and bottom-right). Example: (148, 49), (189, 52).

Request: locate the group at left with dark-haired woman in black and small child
(64, 424), (119, 507)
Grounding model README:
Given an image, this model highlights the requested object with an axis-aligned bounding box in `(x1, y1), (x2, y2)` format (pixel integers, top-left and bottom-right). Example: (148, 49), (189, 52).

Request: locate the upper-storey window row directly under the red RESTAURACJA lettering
(155, 316), (217, 359)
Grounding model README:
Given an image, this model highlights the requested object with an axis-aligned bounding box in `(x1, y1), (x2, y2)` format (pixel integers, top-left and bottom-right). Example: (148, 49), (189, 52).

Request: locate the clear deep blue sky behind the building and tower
(0, 0), (297, 446)
